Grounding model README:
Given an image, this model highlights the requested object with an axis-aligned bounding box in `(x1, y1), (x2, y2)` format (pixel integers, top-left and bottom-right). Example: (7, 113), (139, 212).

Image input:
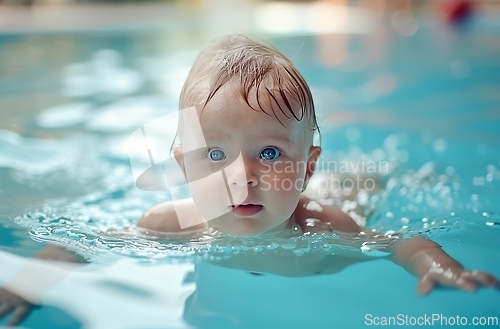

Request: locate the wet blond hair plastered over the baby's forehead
(179, 35), (319, 136)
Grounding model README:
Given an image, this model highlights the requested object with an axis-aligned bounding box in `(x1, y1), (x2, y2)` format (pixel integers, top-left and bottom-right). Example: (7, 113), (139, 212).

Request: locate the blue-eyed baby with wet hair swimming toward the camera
(138, 35), (498, 294)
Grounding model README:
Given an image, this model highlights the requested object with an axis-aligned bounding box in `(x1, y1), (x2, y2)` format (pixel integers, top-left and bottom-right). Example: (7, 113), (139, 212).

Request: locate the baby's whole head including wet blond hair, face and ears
(174, 35), (320, 236)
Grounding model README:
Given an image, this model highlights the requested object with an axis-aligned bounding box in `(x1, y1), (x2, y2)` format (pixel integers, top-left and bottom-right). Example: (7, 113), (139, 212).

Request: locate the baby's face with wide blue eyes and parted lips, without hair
(176, 83), (319, 236)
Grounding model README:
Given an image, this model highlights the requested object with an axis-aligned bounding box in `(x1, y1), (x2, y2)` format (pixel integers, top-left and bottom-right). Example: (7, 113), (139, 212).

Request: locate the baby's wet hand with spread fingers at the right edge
(417, 263), (499, 295)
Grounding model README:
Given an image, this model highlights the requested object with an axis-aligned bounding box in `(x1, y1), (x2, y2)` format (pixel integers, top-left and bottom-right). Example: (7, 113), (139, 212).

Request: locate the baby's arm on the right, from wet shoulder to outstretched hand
(296, 198), (499, 295)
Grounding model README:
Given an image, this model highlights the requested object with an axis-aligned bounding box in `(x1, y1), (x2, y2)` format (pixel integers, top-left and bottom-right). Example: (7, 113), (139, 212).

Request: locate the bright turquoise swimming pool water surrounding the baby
(0, 7), (500, 328)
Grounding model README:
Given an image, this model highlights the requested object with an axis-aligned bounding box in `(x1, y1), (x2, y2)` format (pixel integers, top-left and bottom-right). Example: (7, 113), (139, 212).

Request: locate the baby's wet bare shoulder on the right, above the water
(293, 196), (361, 233)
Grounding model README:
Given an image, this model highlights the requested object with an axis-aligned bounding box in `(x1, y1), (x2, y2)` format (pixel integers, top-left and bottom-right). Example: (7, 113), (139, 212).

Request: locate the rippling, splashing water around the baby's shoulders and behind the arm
(5, 131), (500, 263)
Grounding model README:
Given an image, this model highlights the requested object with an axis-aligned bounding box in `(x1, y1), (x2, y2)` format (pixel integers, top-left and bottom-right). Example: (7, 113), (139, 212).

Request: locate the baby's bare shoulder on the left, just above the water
(137, 199), (207, 233)
